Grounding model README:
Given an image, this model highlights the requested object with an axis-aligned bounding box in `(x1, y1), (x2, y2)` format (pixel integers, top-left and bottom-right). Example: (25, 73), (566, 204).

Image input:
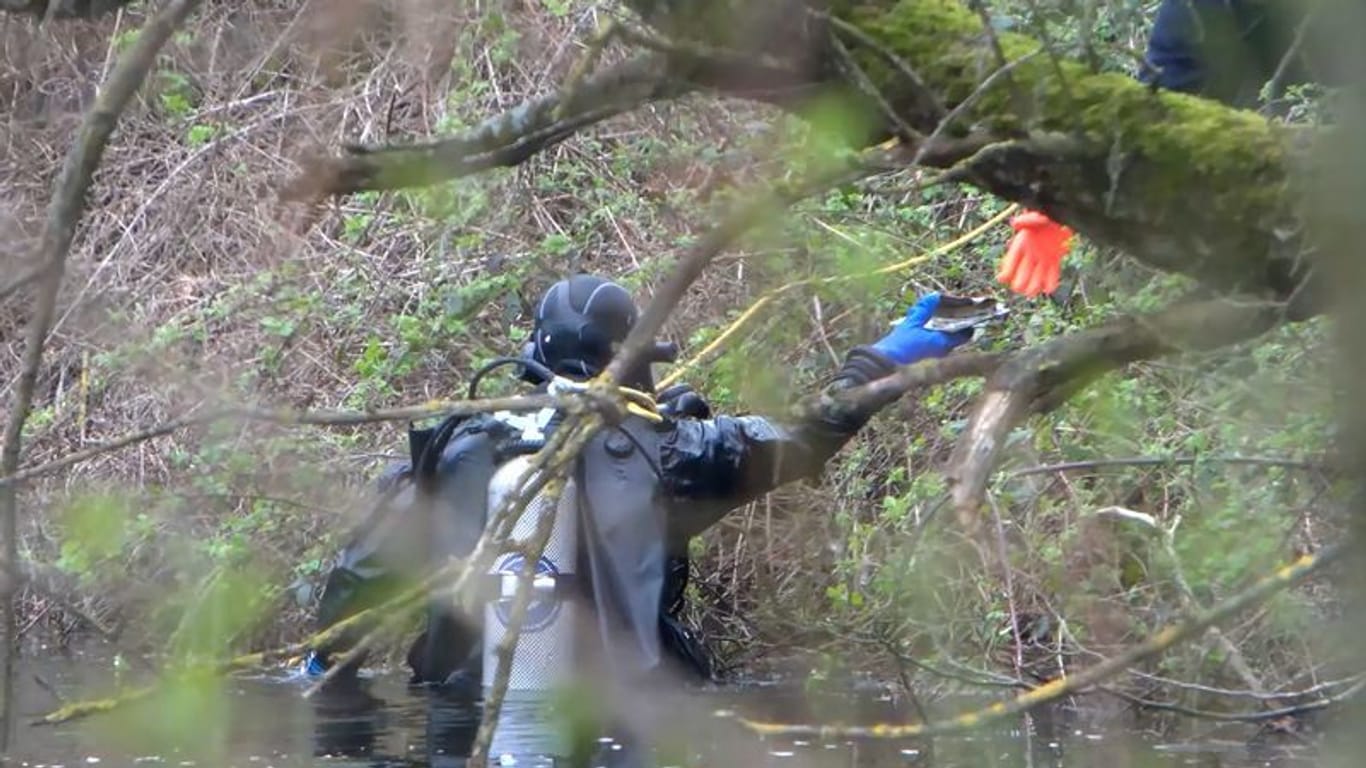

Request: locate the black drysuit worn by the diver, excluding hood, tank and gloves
(317, 347), (895, 683)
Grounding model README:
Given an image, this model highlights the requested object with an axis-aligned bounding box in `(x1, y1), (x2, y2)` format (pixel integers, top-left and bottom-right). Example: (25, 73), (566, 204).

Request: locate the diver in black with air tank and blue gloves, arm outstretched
(293, 275), (973, 721)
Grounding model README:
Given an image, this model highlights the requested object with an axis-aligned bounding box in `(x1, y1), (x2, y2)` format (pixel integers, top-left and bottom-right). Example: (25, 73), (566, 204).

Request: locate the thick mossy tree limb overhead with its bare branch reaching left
(293, 0), (1318, 307)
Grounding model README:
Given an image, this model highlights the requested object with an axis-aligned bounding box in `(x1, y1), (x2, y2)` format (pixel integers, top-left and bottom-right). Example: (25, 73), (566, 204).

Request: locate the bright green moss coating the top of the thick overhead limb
(844, 0), (1285, 221)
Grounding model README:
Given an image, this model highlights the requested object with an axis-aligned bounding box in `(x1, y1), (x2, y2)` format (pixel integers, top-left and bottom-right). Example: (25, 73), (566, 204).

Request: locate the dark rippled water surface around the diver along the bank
(7, 642), (1314, 768)
